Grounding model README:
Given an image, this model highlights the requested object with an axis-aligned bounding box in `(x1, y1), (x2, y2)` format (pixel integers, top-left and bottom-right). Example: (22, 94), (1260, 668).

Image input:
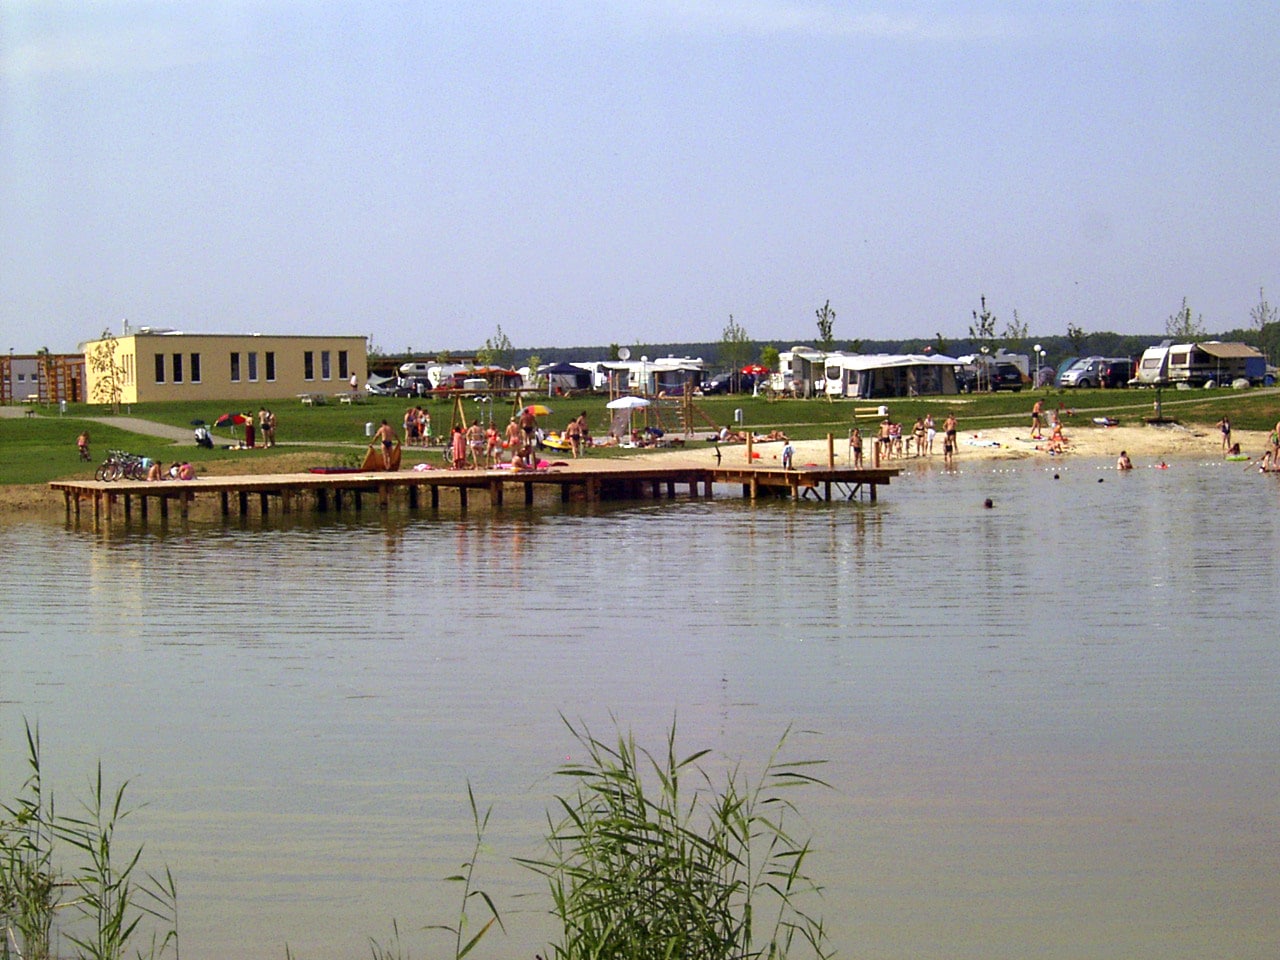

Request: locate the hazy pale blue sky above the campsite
(0, 0), (1280, 352)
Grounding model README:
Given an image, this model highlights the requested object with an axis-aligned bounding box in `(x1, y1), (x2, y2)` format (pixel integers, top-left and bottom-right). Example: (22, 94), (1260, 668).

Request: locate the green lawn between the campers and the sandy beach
(10, 389), (1280, 484)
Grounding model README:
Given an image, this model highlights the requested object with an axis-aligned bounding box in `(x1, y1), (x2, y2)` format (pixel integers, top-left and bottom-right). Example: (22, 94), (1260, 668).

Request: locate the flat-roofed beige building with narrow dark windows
(84, 329), (367, 403)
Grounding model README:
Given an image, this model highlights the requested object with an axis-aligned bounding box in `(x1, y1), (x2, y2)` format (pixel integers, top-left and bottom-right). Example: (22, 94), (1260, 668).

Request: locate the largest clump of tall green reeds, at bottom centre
(522, 717), (831, 960)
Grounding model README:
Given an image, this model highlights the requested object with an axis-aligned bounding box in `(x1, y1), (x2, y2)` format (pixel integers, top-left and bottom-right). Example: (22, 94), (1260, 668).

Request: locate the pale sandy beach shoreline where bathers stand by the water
(0, 420), (1267, 517)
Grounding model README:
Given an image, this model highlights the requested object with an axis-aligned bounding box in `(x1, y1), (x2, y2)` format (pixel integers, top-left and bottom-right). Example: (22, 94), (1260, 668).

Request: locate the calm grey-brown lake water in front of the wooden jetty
(0, 461), (1280, 960)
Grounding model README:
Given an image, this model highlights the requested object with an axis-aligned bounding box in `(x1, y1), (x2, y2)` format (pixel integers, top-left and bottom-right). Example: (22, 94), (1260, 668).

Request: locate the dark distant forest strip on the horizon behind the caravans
(391, 323), (1280, 371)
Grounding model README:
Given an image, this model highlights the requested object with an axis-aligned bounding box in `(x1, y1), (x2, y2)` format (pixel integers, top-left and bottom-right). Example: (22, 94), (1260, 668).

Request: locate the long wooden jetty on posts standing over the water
(49, 458), (899, 526)
